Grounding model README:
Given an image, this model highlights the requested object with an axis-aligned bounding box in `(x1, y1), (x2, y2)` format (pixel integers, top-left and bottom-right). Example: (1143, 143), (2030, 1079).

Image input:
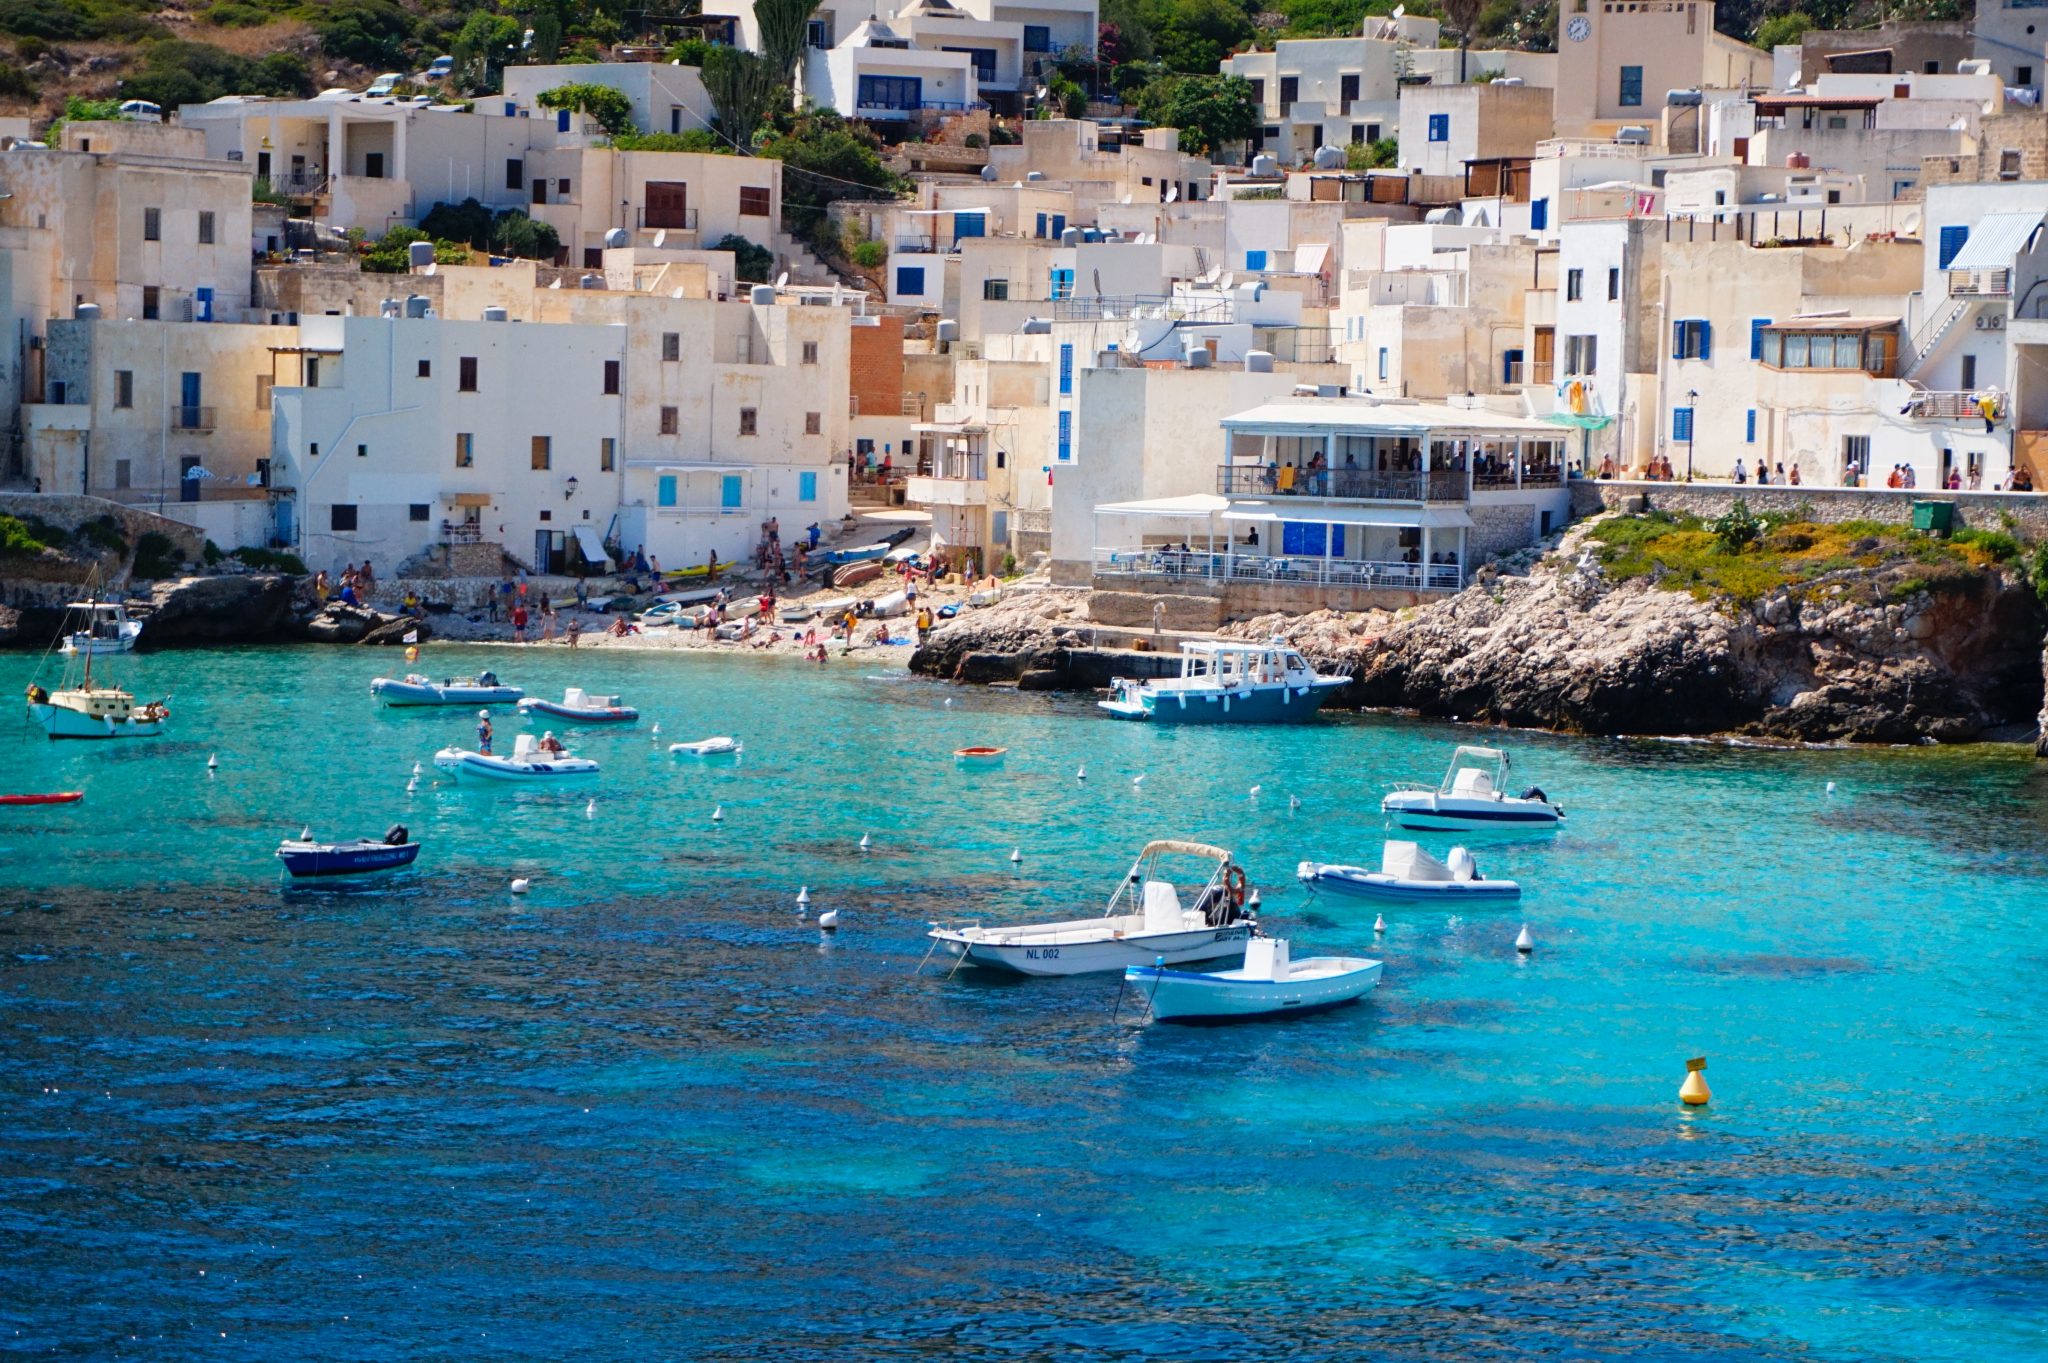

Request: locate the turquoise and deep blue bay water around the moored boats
(0, 649), (2048, 1361)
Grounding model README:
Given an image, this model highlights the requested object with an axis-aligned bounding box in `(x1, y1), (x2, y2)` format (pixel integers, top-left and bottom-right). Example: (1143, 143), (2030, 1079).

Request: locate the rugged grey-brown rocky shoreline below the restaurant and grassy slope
(911, 519), (2048, 743)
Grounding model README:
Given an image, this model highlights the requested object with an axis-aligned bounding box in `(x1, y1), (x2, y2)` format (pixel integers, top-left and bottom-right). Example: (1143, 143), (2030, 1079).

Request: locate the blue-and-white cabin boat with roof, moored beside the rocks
(1096, 639), (1350, 724)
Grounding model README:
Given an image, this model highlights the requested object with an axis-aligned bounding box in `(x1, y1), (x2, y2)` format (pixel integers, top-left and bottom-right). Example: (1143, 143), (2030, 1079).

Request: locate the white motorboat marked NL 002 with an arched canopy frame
(926, 839), (1253, 974)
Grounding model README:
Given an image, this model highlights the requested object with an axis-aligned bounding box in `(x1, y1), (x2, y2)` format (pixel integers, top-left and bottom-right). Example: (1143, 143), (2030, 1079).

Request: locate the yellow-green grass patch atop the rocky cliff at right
(1589, 512), (2021, 604)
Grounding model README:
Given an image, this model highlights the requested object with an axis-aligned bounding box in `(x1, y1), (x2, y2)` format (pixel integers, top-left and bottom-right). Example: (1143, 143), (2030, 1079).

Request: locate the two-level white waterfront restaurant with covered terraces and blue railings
(1096, 386), (1569, 591)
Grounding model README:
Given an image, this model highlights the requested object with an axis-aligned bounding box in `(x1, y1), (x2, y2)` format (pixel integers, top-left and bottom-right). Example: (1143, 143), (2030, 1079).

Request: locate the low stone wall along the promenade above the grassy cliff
(1573, 479), (2048, 542)
